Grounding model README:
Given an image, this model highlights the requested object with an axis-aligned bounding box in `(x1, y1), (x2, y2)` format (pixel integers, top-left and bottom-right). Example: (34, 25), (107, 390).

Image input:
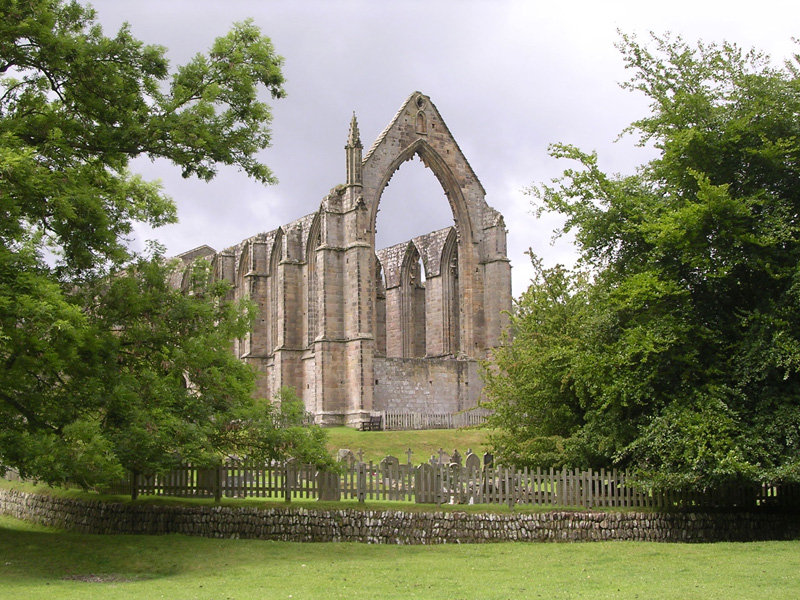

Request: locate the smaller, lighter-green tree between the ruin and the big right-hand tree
(483, 252), (586, 468)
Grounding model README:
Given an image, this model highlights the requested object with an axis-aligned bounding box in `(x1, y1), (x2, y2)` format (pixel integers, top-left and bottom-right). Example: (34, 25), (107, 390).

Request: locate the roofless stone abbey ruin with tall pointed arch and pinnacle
(175, 92), (511, 426)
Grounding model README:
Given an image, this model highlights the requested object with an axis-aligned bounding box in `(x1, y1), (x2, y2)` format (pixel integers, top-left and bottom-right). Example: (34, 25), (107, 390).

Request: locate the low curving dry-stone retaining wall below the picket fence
(0, 489), (800, 544)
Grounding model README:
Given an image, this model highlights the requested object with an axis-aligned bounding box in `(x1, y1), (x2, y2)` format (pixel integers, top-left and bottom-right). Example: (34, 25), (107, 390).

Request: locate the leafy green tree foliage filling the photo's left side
(0, 0), (332, 485)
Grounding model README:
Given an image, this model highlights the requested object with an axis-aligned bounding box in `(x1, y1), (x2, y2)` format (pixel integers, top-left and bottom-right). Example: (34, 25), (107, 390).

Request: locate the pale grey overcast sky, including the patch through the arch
(86, 0), (800, 296)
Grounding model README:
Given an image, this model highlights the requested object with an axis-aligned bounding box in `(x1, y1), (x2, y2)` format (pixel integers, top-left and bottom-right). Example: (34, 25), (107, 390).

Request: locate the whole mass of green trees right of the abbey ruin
(487, 36), (800, 488)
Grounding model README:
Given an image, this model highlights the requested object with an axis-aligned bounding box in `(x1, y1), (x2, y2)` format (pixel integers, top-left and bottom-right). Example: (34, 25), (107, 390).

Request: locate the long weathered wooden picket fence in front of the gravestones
(98, 454), (800, 509)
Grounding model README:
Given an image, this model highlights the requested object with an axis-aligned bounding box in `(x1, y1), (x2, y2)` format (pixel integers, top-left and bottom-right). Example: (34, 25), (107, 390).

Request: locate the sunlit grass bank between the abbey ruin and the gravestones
(326, 427), (489, 465)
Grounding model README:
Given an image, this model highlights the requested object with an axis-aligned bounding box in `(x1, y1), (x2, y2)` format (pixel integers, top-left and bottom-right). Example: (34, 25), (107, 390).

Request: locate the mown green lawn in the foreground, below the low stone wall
(0, 517), (800, 600)
